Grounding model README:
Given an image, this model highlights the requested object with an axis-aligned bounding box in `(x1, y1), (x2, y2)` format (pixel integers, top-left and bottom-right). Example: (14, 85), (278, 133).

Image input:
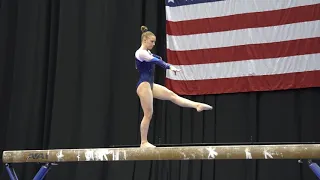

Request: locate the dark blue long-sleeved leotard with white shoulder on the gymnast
(135, 49), (170, 88)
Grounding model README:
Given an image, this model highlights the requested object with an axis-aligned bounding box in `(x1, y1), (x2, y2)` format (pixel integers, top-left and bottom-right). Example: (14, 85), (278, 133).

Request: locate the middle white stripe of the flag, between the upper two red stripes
(167, 20), (320, 51)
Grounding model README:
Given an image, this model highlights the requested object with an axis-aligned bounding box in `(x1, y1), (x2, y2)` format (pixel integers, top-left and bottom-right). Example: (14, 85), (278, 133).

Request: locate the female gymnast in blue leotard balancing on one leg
(135, 26), (212, 148)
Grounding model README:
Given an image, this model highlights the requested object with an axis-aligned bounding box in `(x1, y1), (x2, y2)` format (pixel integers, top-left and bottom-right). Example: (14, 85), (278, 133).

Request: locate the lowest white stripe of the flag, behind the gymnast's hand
(166, 53), (320, 80)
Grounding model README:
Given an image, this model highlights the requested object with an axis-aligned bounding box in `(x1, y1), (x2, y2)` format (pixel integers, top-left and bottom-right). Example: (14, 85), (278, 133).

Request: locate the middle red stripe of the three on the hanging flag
(167, 37), (320, 65)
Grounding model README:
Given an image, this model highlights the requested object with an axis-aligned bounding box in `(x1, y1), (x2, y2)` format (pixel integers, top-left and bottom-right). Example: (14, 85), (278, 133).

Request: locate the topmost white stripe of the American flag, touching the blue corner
(166, 0), (320, 22)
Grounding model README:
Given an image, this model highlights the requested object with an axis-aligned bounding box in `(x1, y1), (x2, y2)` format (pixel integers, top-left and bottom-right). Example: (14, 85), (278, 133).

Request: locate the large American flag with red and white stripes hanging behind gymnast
(165, 0), (320, 95)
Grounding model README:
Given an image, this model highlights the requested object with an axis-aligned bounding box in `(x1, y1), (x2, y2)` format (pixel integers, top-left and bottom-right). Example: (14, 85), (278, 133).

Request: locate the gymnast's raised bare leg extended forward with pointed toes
(152, 83), (212, 112)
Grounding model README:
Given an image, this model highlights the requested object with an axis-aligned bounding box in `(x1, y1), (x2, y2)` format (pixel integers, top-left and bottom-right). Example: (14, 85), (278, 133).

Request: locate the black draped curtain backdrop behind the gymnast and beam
(0, 0), (320, 180)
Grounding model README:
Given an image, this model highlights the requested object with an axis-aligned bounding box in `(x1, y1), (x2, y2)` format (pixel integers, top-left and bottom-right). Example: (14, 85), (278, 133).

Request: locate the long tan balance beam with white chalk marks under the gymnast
(2, 144), (320, 164)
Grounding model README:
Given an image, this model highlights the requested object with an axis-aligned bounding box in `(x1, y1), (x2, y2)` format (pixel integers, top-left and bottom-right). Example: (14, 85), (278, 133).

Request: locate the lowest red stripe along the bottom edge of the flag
(165, 71), (320, 95)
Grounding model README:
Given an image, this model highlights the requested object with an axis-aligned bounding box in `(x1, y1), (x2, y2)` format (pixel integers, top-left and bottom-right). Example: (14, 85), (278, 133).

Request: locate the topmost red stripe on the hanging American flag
(166, 4), (320, 36)
